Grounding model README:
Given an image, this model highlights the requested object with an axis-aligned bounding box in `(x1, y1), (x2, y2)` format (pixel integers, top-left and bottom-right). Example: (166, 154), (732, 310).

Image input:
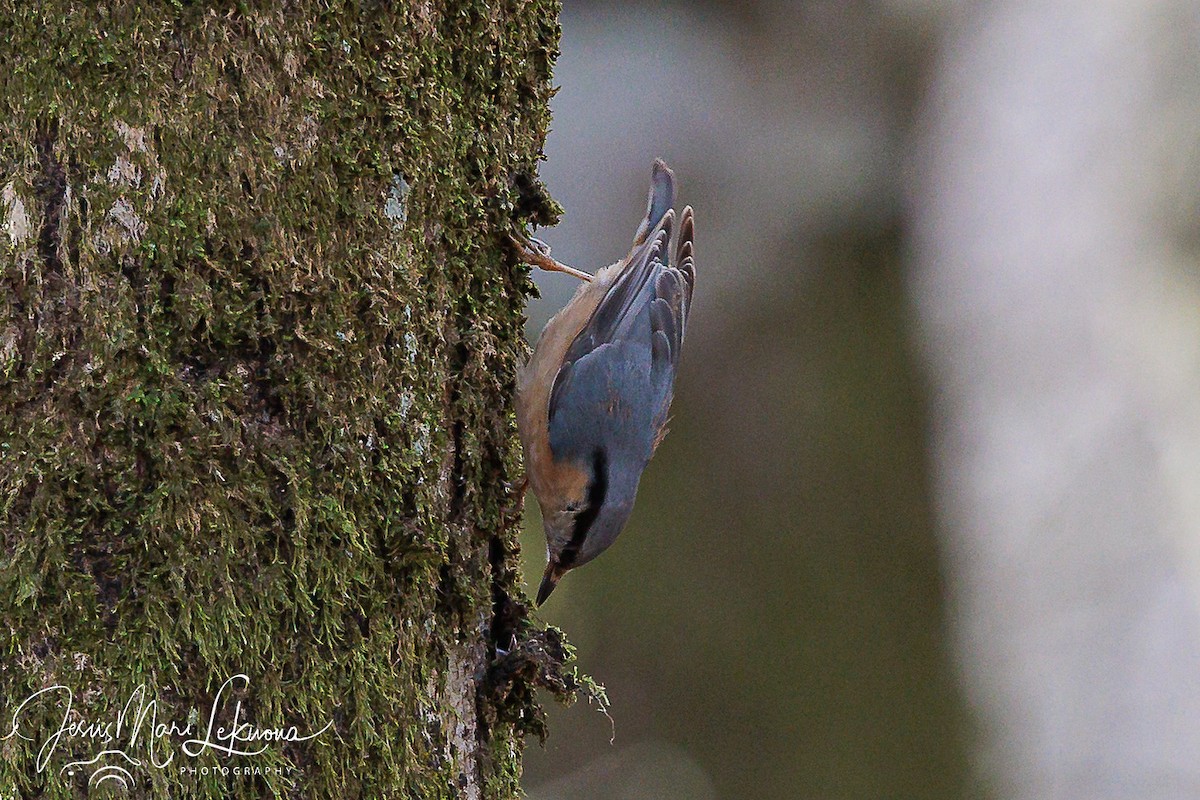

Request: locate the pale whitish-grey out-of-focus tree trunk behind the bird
(912, 0), (1200, 800)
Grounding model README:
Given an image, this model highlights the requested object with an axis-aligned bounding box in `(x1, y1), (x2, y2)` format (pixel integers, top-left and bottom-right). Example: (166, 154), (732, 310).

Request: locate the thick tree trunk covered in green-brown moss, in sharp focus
(0, 0), (560, 798)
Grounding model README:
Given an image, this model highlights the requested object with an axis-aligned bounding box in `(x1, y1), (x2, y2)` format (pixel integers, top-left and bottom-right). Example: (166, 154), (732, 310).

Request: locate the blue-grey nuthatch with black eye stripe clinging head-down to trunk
(510, 158), (696, 607)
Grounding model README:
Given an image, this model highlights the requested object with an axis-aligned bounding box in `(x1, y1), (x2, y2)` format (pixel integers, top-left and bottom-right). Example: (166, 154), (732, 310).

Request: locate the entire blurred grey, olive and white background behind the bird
(524, 0), (1200, 800)
